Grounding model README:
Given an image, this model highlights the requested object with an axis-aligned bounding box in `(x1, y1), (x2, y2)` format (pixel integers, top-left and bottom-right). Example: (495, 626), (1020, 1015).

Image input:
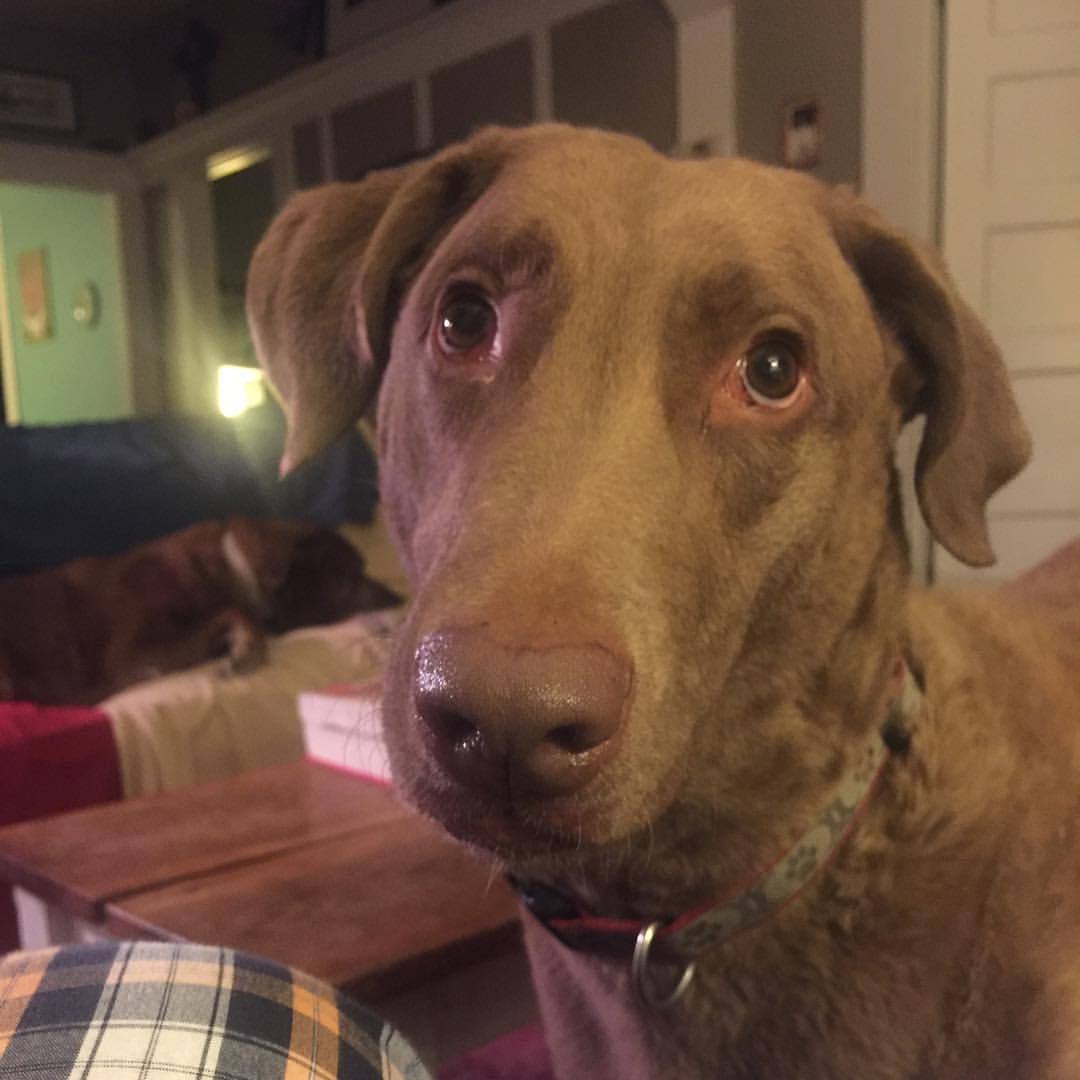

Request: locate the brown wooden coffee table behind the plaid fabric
(0, 760), (535, 1058)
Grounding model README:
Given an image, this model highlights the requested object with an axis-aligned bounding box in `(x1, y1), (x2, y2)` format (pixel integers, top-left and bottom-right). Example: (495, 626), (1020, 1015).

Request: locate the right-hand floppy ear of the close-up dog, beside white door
(828, 188), (1031, 566)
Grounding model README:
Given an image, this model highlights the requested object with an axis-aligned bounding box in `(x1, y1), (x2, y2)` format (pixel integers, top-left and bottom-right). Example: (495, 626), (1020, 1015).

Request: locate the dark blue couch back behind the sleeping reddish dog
(0, 405), (377, 576)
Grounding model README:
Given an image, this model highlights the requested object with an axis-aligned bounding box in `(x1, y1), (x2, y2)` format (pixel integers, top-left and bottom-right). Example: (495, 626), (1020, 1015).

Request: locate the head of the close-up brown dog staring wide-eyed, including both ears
(248, 125), (1028, 902)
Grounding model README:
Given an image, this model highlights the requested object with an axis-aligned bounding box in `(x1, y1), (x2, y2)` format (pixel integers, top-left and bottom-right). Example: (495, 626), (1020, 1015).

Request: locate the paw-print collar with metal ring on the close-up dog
(510, 660), (922, 1008)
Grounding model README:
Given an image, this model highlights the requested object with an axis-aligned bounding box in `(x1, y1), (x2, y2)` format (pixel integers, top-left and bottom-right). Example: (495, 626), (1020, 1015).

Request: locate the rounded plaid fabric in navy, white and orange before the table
(0, 942), (430, 1080)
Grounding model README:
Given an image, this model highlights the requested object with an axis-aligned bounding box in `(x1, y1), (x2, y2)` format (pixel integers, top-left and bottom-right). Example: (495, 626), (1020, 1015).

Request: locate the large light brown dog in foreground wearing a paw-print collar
(248, 126), (1080, 1080)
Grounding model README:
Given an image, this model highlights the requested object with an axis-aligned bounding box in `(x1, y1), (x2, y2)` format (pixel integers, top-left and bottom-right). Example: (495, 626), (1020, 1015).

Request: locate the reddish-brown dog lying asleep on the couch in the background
(0, 517), (397, 705)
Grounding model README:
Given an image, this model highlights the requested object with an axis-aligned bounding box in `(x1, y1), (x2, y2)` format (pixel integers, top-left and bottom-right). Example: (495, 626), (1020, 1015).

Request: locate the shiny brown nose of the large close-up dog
(416, 627), (631, 797)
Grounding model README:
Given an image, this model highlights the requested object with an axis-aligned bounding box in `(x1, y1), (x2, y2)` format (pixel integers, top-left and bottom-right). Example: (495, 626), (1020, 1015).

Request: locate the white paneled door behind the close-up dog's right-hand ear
(934, 0), (1080, 582)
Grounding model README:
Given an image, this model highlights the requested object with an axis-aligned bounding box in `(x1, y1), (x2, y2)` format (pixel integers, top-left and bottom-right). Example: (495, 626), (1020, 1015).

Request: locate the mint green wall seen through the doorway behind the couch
(0, 184), (132, 423)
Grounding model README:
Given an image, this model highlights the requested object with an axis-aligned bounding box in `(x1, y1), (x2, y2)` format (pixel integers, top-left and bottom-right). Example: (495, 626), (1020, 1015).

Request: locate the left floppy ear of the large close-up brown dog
(247, 129), (512, 473)
